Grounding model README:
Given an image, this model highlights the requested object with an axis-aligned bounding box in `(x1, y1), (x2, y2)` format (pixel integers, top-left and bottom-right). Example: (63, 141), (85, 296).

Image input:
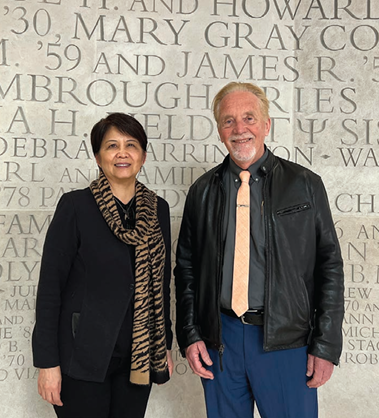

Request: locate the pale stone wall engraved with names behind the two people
(0, 0), (379, 418)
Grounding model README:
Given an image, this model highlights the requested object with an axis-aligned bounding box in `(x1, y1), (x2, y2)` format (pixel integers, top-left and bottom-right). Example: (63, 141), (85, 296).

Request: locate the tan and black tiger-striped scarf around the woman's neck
(90, 170), (169, 385)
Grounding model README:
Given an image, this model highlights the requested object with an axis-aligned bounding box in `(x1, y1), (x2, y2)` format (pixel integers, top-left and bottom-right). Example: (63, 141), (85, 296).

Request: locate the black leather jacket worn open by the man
(175, 152), (344, 364)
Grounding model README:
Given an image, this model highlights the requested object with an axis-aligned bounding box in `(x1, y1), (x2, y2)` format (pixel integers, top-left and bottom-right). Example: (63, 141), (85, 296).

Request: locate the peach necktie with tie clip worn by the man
(232, 171), (250, 317)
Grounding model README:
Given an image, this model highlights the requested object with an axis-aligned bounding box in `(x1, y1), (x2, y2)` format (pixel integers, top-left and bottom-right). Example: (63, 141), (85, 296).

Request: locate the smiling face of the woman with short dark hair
(96, 126), (146, 184)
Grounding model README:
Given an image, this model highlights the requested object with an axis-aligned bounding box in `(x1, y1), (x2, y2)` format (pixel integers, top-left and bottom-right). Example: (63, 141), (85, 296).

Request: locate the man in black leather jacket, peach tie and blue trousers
(175, 83), (343, 418)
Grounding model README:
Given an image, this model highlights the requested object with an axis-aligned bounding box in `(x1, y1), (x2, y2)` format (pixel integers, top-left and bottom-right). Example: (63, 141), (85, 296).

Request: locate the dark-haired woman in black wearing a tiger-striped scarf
(33, 113), (173, 418)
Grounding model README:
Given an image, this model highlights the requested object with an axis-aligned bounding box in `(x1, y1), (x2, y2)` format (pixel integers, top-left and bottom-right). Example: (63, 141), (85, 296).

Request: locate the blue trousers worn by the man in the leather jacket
(202, 314), (318, 418)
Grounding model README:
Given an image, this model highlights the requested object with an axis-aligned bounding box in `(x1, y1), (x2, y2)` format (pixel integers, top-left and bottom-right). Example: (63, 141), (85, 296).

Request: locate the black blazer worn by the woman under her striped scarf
(32, 188), (172, 382)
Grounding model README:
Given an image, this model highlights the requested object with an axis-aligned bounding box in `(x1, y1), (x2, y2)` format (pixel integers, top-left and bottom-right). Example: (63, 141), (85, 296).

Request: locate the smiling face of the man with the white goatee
(218, 91), (271, 170)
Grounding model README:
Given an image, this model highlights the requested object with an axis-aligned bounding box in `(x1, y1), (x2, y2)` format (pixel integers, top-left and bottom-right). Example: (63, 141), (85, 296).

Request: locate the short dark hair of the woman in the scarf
(91, 113), (147, 155)
